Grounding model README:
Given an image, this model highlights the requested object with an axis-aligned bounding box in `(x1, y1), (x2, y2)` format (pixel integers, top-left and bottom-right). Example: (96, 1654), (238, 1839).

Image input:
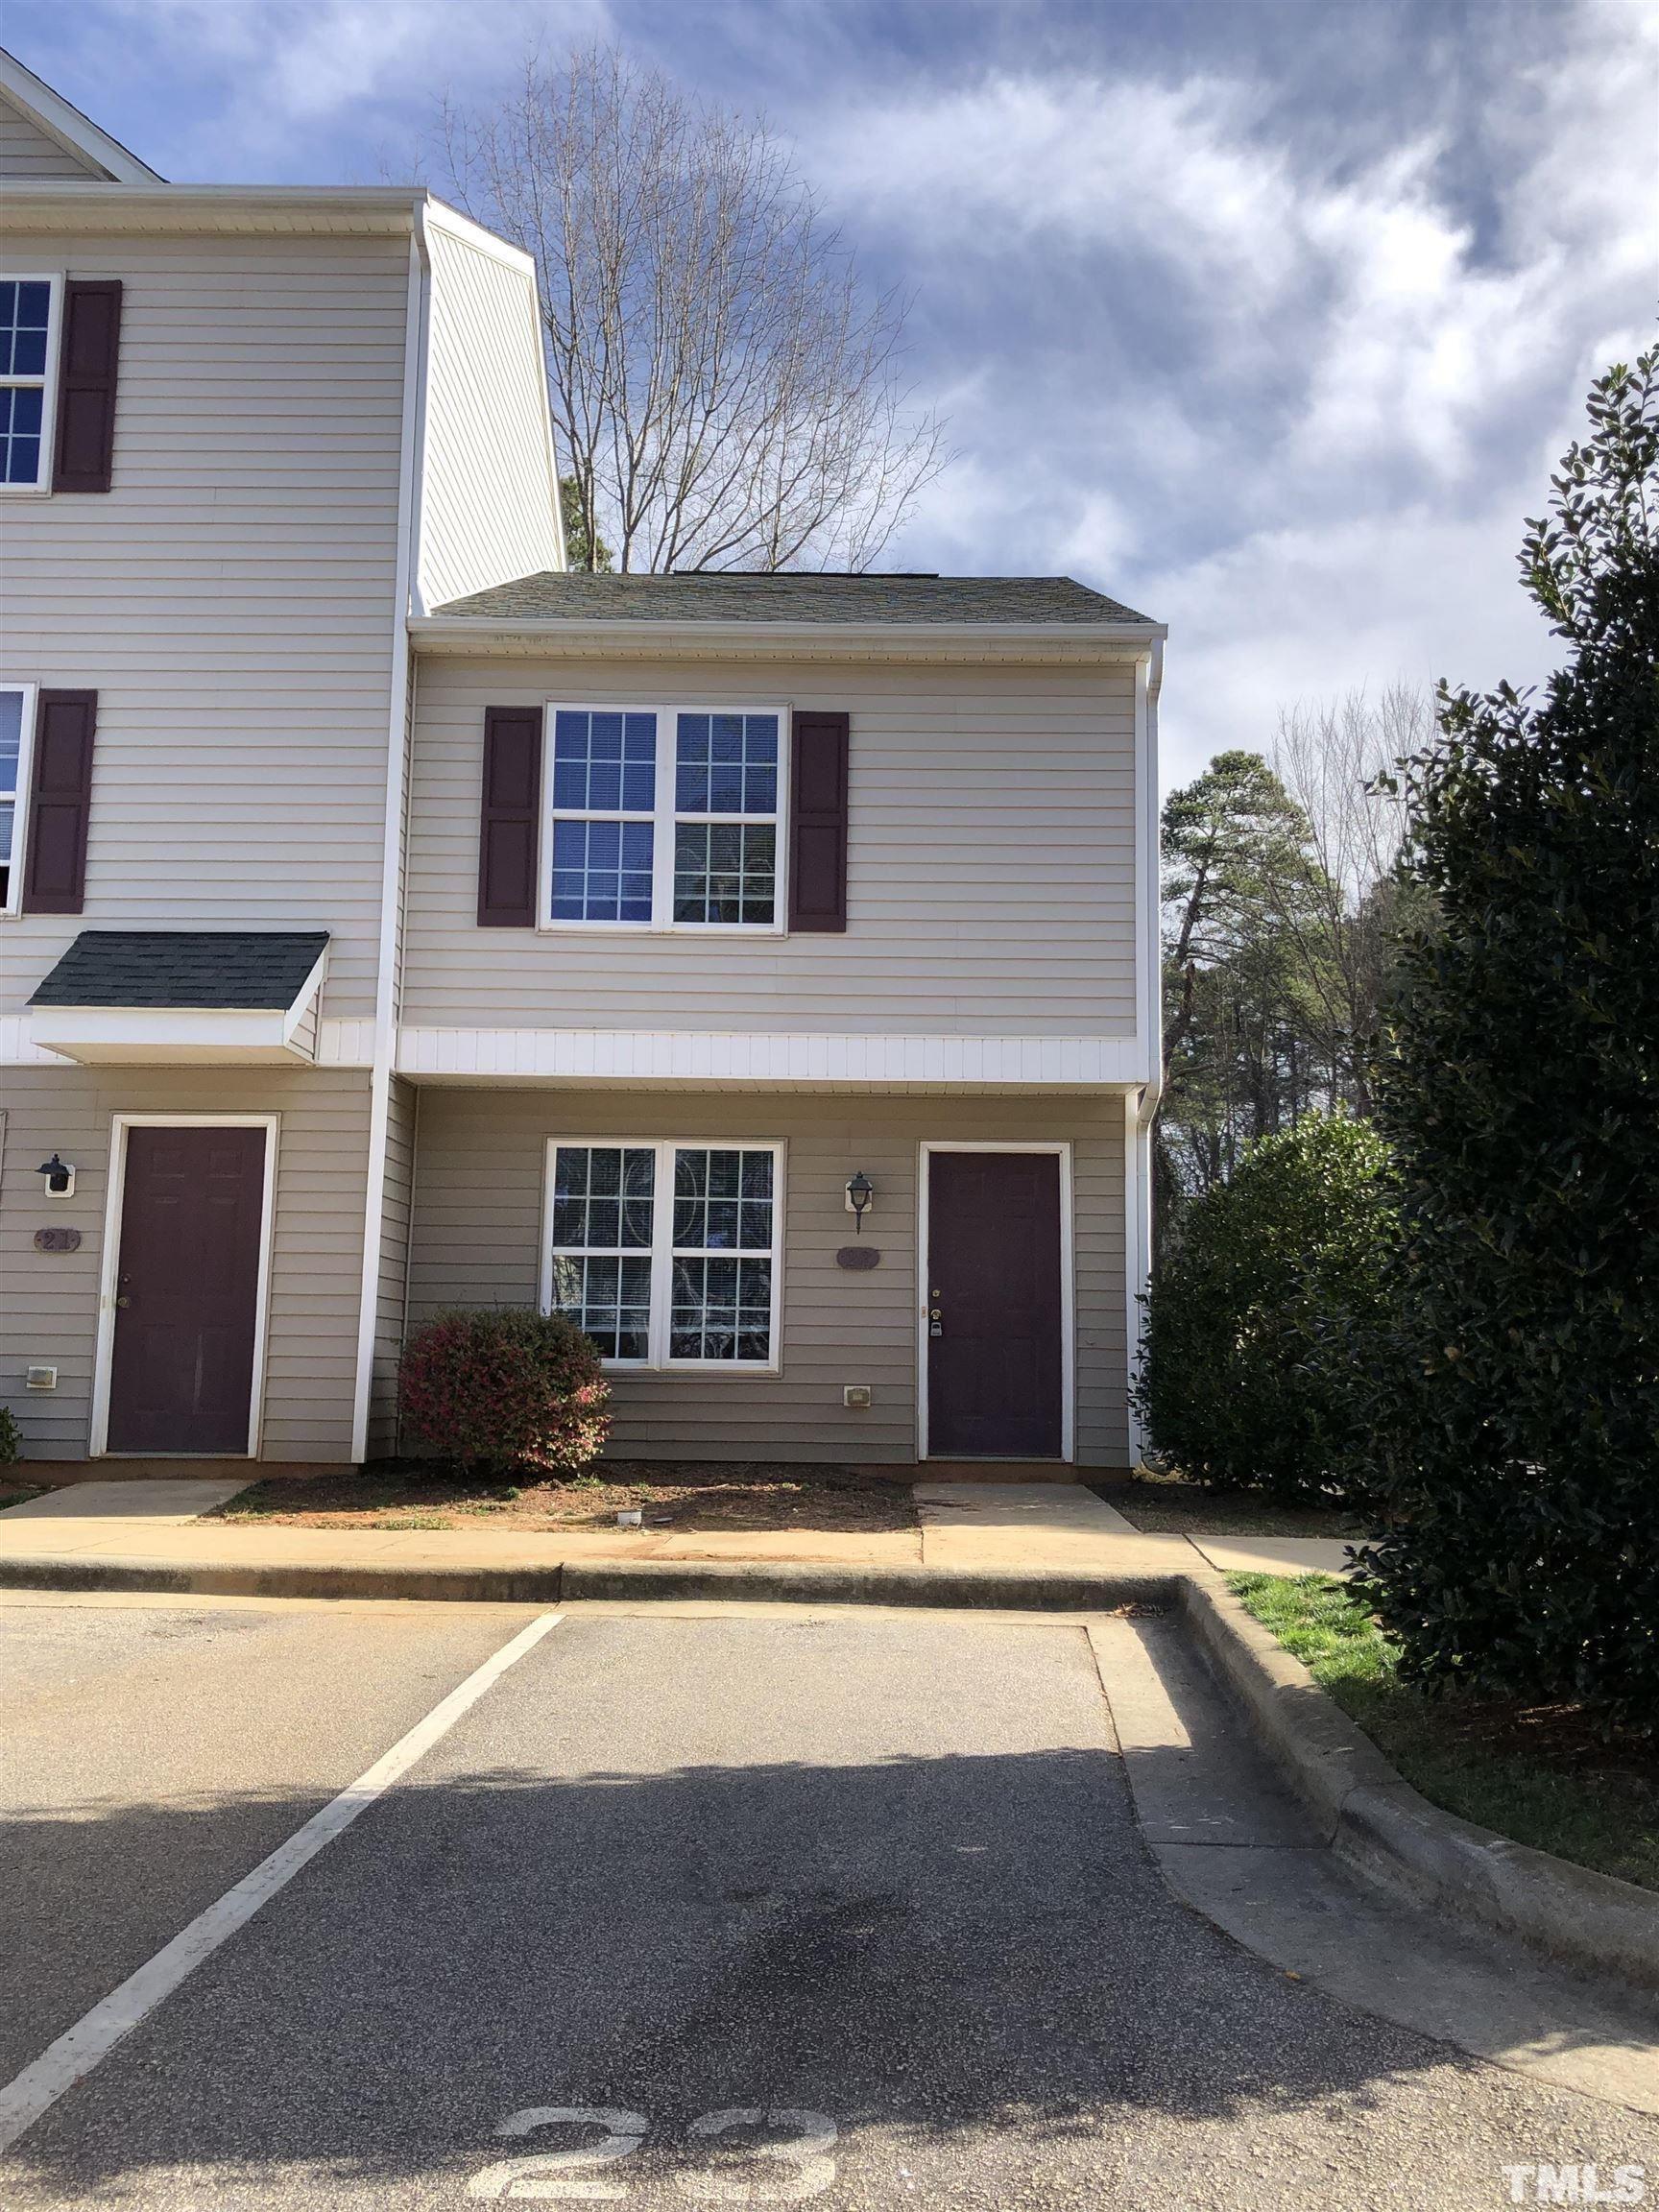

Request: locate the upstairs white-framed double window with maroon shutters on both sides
(540, 704), (787, 933)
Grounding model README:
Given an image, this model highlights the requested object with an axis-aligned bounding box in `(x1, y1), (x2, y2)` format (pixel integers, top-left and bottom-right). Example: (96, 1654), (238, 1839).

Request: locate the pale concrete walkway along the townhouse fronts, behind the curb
(0, 1479), (1347, 1575)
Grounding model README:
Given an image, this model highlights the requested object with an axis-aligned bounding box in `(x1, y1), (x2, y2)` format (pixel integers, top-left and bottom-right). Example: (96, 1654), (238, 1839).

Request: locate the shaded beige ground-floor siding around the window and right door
(409, 1086), (1128, 1467)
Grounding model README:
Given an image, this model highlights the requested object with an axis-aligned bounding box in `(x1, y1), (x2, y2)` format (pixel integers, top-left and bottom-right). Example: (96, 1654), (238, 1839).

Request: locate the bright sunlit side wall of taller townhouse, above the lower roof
(421, 208), (562, 609)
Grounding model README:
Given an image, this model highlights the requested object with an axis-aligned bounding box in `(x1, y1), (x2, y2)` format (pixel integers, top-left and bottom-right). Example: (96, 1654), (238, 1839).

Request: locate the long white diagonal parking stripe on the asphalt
(0, 1613), (562, 2152)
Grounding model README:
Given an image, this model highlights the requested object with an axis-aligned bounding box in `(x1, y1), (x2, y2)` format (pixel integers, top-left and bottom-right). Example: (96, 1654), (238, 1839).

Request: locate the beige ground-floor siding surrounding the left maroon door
(0, 1069), (370, 1460)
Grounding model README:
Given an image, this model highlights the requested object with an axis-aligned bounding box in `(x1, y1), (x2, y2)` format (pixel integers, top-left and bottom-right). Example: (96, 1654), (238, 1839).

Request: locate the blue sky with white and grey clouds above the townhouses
(5, 0), (1659, 781)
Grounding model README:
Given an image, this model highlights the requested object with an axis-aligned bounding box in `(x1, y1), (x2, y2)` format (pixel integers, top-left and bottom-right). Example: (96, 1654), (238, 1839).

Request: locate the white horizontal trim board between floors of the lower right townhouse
(398, 1026), (1150, 1091)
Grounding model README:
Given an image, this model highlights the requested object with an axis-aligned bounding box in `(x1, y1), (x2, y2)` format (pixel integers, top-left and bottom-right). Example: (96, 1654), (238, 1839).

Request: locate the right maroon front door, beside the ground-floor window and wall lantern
(923, 1152), (1064, 1460)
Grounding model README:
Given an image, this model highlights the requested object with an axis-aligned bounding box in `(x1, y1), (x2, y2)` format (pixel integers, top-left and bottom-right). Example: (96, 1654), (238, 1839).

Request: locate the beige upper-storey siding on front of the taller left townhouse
(0, 233), (409, 1018)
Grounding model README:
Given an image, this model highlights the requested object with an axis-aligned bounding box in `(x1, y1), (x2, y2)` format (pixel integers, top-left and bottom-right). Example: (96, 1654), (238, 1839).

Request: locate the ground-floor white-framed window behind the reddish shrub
(541, 1137), (783, 1374)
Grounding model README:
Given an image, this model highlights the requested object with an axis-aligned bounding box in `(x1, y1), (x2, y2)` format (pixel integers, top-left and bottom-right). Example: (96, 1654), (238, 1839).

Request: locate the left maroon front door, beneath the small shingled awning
(107, 1126), (268, 1454)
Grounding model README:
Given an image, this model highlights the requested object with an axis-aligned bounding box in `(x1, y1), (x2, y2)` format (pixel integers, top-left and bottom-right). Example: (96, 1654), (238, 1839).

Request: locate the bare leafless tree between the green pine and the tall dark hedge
(1272, 684), (1433, 1113)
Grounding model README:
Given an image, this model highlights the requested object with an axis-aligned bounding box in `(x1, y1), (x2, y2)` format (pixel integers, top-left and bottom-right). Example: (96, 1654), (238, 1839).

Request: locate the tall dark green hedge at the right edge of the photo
(1360, 351), (1659, 1725)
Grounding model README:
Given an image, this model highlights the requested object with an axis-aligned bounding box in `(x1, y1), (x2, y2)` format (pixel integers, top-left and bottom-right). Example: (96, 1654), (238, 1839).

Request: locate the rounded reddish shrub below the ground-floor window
(398, 1308), (611, 1473)
